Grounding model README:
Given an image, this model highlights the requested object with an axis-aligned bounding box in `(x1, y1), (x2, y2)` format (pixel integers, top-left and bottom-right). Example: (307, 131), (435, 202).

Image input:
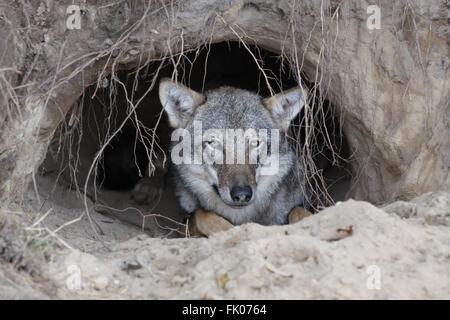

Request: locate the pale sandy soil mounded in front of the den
(12, 172), (450, 299)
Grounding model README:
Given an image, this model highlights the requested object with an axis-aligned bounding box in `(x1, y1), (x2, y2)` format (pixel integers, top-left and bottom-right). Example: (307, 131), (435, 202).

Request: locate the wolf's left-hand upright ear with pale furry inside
(159, 78), (205, 128)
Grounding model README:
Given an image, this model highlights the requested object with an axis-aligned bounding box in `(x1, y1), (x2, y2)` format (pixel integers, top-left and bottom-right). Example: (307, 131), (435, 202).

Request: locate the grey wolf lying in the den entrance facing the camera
(159, 78), (307, 225)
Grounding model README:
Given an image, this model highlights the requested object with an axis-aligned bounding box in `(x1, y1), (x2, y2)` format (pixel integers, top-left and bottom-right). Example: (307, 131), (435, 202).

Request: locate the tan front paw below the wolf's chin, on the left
(188, 209), (233, 237)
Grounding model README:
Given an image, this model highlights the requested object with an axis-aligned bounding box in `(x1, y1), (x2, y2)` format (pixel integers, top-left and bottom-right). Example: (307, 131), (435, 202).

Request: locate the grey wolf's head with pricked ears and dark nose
(159, 79), (306, 221)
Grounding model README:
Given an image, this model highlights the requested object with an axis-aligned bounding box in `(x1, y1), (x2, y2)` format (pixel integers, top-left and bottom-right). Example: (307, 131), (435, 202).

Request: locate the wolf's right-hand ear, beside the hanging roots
(262, 87), (306, 131)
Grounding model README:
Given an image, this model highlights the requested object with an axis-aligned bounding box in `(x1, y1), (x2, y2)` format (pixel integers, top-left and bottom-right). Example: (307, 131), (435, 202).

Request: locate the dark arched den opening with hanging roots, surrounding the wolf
(33, 42), (350, 238)
